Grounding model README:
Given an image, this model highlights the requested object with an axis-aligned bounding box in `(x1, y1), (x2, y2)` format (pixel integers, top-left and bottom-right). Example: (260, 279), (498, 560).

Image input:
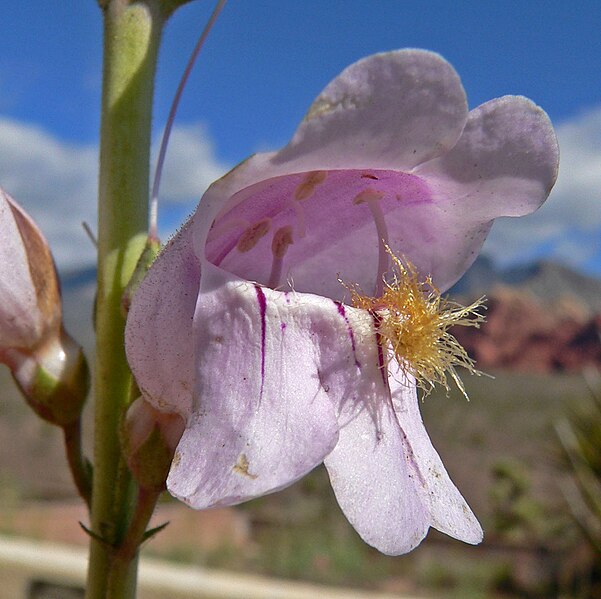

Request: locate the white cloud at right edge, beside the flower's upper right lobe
(485, 107), (601, 265)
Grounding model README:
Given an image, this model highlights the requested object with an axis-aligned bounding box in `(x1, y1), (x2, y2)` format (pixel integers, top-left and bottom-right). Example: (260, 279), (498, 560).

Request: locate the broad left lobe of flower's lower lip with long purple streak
(167, 264), (347, 508)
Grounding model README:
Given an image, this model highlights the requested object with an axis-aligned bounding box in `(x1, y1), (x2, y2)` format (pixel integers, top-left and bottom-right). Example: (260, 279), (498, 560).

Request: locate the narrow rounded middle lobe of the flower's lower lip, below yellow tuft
(324, 308), (430, 555)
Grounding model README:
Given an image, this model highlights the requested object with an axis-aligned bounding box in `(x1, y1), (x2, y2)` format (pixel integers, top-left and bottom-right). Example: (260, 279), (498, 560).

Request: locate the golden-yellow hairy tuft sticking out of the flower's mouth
(343, 247), (484, 397)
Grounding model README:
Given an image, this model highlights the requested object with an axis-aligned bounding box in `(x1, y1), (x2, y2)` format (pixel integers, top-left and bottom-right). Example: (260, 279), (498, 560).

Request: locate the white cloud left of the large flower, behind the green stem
(0, 119), (226, 269)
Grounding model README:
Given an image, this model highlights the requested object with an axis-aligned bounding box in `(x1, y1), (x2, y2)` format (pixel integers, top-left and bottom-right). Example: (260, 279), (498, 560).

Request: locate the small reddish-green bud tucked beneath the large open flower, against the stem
(122, 397), (185, 491)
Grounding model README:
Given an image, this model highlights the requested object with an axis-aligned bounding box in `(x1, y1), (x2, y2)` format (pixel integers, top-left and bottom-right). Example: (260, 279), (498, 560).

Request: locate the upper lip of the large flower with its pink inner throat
(195, 60), (558, 299)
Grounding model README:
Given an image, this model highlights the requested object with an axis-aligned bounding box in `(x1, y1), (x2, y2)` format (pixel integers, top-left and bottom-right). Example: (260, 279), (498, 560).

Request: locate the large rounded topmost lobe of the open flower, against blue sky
(274, 50), (467, 171)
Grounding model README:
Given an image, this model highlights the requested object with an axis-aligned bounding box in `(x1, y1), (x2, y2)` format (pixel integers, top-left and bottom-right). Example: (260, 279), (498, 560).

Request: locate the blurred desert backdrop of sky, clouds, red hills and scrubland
(0, 0), (601, 597)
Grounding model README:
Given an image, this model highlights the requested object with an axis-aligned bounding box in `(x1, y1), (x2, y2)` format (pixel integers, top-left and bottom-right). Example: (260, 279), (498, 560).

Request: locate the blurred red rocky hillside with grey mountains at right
(451, 259), (601, 372)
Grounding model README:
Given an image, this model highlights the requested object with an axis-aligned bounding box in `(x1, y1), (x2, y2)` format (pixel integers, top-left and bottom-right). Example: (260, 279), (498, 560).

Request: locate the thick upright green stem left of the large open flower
(86, 0), (166, 599)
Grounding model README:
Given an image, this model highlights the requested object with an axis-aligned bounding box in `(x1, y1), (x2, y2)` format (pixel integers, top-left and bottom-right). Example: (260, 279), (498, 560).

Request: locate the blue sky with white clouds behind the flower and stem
(0, 0), (601, 275)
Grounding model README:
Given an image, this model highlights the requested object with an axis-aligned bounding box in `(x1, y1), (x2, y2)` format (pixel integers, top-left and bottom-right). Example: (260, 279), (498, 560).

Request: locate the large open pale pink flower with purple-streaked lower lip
(126, 50), (558, 555)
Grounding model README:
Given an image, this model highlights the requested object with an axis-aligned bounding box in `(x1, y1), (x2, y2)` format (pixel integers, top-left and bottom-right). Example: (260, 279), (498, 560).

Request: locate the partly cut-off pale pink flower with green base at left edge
(0, 189), (89, 426)
